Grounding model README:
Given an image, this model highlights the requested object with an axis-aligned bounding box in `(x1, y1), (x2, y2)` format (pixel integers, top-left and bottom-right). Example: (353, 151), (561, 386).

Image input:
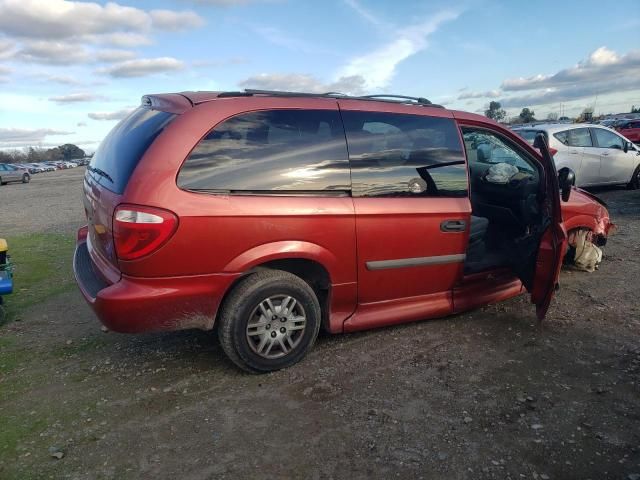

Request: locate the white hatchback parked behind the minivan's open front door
(513, 123), (640, 189)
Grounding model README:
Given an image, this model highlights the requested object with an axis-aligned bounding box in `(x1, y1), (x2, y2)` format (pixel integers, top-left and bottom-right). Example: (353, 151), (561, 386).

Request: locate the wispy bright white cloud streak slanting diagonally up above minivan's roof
(338, 10), (459, 90)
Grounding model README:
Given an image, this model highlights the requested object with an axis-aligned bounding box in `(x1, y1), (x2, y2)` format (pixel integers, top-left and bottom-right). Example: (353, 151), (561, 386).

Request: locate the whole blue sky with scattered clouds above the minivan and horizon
(0, 0), (640, 151)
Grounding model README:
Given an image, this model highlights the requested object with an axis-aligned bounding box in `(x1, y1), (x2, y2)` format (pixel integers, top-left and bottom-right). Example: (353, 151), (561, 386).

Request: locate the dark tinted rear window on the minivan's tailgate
(87, 107), (176, 194)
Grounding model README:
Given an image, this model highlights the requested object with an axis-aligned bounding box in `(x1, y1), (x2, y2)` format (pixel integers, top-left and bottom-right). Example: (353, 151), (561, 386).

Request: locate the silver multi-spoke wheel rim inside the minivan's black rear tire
(247, 295), (307, 359)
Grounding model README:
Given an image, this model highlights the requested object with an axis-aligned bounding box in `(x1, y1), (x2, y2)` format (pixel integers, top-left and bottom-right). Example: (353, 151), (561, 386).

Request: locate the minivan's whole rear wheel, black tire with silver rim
(218, 270), (321, 373)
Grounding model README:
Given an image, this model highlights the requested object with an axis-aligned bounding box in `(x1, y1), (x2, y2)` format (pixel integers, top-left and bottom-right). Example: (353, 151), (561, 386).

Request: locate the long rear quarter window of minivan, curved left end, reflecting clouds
(178, 110), (351, 193)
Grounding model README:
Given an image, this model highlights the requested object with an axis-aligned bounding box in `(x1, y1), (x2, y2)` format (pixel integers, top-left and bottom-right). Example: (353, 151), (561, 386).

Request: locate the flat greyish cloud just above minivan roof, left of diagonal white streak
(238, 73), (365, 95)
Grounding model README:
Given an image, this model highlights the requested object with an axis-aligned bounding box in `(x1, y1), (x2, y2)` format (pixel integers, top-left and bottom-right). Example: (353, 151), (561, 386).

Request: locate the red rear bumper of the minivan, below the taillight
(73, 242), (240, 333)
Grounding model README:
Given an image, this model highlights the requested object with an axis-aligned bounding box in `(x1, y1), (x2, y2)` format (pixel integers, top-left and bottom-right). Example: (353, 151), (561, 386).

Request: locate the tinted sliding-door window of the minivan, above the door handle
(342, 111), (467, 197)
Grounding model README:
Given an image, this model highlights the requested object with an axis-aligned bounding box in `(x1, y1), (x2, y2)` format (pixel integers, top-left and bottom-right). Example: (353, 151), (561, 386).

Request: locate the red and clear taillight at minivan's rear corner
(113, 205), (178, 260)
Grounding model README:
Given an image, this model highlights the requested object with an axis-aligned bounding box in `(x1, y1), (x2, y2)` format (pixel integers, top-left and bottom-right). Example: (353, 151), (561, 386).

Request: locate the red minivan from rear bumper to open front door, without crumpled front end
(74, 90), (571, 372)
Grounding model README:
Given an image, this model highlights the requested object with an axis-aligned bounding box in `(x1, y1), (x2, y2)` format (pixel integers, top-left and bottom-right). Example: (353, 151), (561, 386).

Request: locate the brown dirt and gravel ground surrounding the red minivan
(0, 169), (640, 480)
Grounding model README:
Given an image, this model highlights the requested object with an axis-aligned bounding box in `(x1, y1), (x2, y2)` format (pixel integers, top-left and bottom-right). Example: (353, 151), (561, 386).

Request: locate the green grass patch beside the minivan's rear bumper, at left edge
(4, 233), (75, 322)
